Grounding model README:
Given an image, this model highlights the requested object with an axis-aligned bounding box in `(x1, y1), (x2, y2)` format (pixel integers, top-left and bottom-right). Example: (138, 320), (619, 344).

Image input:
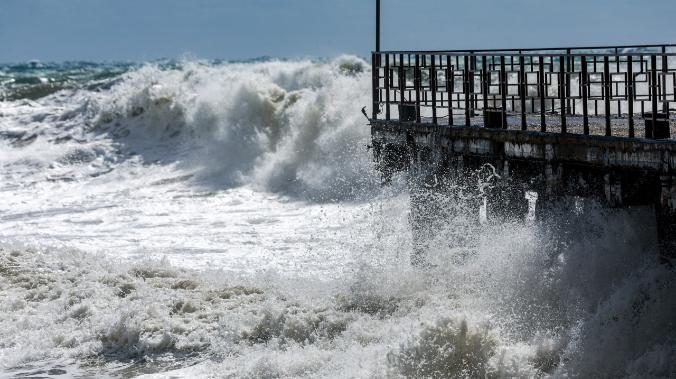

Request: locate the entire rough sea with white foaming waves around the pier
(0, 56), (676, 378)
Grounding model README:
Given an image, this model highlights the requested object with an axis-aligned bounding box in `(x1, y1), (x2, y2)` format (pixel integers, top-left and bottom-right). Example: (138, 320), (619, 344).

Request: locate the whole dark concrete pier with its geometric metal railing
(367, 45), (676, 260)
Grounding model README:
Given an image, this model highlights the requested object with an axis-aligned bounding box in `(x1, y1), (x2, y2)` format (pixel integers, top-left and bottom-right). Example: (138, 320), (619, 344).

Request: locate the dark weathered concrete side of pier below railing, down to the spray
(372, 120), (676, 257)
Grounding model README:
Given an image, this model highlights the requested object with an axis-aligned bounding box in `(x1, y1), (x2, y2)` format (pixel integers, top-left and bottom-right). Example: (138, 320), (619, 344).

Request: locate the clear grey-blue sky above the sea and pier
(0, 0), (676, 62)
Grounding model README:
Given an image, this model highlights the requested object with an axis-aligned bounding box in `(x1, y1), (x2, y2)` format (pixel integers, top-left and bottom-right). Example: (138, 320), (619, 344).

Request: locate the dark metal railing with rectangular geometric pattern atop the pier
(372, 45), (676, 138)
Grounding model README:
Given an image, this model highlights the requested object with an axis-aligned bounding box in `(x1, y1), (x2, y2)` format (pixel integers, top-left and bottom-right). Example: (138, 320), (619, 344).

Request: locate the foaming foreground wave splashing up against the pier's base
(0, 200), (676, 378)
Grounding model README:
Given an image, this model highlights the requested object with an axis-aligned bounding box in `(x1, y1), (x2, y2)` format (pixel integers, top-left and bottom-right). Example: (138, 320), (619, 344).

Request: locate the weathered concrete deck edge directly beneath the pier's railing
(372, 120), (676, 172)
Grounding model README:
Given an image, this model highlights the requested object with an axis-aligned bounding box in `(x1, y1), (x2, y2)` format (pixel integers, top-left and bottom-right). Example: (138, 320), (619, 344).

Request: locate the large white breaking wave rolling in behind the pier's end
(0, 56), (376, 200)
